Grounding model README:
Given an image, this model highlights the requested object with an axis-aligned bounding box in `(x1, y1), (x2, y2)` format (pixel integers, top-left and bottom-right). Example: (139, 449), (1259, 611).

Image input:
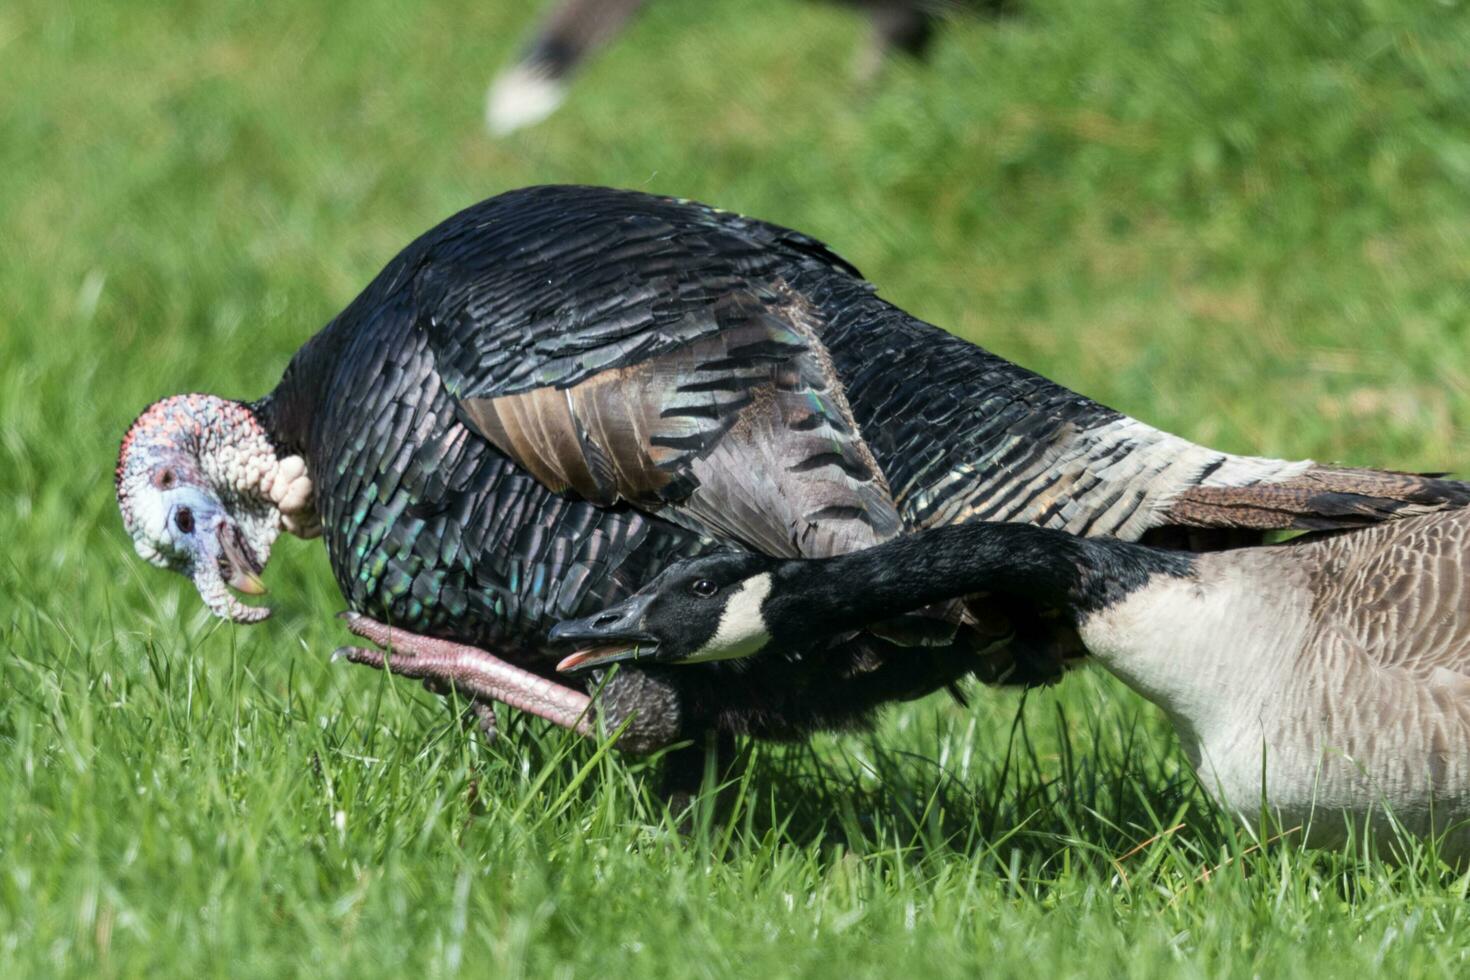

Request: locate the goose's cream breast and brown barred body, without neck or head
(1105, 513), (1470, 857)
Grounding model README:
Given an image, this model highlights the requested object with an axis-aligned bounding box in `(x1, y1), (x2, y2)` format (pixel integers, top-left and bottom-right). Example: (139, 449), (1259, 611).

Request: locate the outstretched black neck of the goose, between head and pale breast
(767, 522), (1194, 636)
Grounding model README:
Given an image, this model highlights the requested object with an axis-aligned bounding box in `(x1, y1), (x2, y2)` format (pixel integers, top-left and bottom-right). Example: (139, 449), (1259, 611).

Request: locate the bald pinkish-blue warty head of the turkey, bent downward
(116, 395), (310, 623)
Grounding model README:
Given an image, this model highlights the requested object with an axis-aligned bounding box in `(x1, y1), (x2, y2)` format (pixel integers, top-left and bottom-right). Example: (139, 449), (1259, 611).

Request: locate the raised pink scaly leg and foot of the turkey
(332, 613), (595, 736)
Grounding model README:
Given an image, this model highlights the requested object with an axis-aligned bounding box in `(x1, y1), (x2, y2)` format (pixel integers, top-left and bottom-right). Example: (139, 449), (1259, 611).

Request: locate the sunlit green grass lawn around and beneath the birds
(0, 0), (1470, 977)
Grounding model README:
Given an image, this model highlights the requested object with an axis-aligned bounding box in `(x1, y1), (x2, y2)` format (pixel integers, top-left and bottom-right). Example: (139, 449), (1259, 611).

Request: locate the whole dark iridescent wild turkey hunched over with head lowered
(118, 187), (1470, 775)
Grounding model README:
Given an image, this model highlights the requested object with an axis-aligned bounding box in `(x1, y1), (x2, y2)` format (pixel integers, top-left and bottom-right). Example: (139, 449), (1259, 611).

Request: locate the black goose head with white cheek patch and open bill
(551, 554), (782, 671)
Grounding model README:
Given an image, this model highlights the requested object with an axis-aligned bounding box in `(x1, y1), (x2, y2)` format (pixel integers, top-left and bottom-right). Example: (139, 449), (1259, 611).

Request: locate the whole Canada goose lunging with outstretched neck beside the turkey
(551, 511), (1470, 857)
